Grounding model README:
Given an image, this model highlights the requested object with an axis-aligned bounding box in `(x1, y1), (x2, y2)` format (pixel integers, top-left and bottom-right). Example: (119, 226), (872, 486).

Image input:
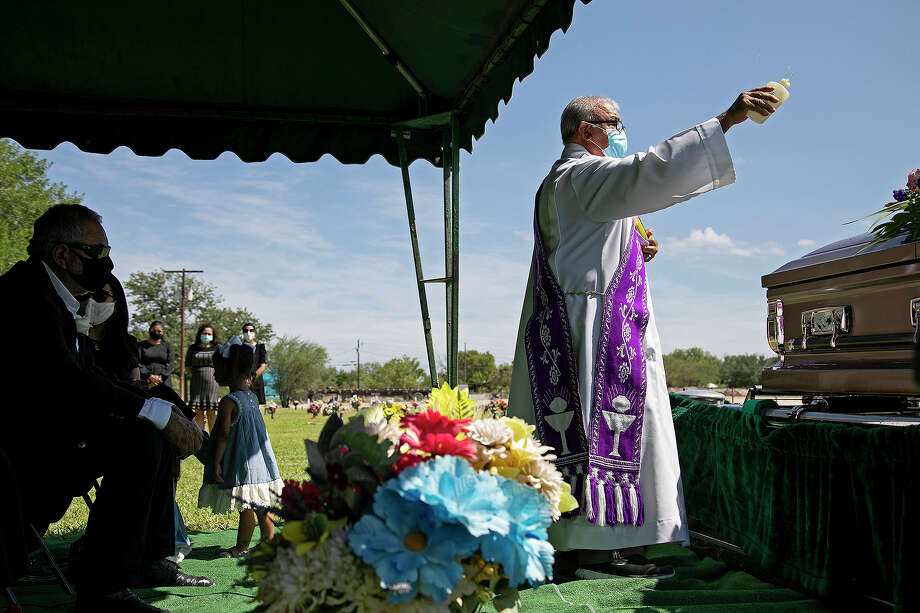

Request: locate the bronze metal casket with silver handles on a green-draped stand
(761, 233), (920, 396)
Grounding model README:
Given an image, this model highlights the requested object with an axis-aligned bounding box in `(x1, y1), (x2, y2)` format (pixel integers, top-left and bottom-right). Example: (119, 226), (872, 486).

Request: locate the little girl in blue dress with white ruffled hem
(198, 340), (284, 558)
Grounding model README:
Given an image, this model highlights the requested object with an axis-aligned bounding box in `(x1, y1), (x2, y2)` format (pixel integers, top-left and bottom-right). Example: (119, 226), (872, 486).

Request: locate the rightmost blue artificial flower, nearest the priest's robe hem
(479, 479), (553, 586)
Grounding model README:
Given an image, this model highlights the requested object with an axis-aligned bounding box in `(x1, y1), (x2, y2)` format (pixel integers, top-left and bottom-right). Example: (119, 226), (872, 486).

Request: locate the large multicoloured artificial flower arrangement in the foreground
(244, 385), (577, 613)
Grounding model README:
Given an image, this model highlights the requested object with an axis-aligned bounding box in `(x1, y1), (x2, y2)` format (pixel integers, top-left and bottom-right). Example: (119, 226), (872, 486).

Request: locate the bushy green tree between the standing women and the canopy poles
(267, 336), (332, 406)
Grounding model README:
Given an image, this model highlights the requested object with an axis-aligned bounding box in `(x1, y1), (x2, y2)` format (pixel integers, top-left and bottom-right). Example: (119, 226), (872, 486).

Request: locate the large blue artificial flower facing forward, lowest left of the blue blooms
(348, 479), (478, 604)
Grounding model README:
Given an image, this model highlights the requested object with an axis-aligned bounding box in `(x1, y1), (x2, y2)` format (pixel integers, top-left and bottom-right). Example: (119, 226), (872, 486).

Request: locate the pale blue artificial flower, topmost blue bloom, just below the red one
(396, 456), (513, 536)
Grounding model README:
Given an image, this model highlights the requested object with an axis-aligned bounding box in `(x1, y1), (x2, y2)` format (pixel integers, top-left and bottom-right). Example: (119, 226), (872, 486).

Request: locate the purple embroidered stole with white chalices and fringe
(524, 193), (648, 526)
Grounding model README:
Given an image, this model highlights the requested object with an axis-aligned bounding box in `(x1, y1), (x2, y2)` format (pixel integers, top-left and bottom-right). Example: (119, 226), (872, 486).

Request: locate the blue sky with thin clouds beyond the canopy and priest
(25, 0), (920, 365)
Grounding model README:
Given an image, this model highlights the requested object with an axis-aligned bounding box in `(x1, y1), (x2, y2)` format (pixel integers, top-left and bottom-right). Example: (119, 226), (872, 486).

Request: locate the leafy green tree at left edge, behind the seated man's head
(0, 138), (83, 274)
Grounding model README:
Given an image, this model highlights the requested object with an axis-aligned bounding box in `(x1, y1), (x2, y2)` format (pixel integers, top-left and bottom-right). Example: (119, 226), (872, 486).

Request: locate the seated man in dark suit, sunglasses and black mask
(0, 204), (211, 612)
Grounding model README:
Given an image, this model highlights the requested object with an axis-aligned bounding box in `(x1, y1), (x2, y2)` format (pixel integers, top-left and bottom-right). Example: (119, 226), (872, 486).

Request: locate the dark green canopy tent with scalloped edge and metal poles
(0, 0), (589, 385)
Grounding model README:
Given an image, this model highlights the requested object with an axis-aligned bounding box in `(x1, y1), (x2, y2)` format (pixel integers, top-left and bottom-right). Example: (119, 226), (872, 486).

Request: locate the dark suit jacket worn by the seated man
(0, 258), (145, 464)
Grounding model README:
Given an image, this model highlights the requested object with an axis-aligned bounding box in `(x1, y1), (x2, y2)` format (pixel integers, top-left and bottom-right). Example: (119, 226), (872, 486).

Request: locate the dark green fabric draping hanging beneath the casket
(671, 394), (920, 608)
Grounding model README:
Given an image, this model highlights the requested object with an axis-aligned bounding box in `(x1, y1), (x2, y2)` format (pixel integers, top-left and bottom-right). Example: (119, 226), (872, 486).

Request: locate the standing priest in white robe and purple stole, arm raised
(508, 87), (777, 579)
